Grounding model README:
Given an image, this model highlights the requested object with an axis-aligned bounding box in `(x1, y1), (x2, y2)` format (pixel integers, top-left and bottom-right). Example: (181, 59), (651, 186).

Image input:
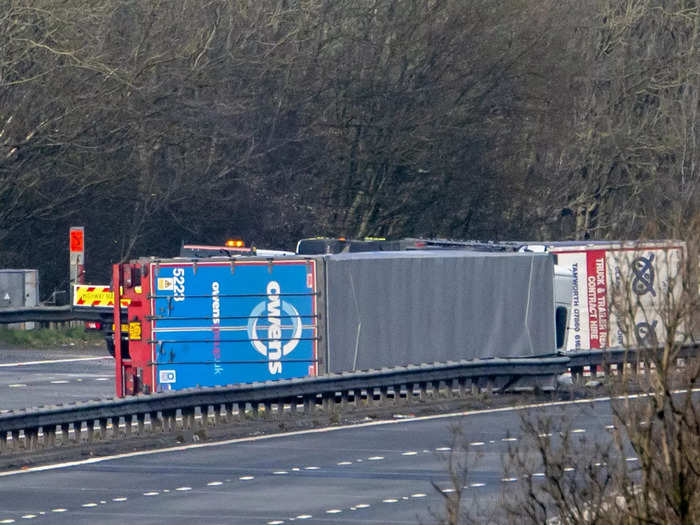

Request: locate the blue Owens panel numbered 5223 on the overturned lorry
(150, 259), (317, 390)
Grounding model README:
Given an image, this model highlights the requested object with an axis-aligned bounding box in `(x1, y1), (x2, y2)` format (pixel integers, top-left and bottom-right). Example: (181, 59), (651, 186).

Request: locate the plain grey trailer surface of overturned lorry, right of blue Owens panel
(325, 251), (555, 372)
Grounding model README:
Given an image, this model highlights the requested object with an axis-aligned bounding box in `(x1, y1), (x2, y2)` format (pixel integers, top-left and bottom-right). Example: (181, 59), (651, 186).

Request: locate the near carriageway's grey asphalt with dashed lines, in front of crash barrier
(0, 401), (624, 525)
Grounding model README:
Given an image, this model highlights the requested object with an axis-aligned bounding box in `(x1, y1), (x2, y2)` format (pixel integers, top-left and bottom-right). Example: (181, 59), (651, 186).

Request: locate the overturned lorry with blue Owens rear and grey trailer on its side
(113, 249), (572, 396)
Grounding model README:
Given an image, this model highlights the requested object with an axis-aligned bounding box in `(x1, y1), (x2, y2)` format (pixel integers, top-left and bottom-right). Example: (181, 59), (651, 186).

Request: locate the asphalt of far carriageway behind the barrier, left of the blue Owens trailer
(0, 348), (114, 411)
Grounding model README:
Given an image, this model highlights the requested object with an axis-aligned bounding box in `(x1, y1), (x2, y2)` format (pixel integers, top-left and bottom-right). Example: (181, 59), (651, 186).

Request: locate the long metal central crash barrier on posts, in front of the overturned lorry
(0, 345), (698, 455)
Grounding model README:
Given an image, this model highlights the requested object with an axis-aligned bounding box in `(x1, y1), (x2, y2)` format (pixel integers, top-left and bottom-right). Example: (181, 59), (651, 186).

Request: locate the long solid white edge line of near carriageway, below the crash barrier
(5, 388), (700, 477)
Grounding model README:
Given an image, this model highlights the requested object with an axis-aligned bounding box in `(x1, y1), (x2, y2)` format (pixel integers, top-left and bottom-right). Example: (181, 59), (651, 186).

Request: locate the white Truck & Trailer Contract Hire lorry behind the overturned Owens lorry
(297, 238), (693, 352)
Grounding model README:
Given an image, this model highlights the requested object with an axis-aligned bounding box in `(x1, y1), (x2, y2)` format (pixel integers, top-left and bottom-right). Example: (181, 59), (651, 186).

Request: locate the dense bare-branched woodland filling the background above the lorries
(0, 0), (700, 296)
